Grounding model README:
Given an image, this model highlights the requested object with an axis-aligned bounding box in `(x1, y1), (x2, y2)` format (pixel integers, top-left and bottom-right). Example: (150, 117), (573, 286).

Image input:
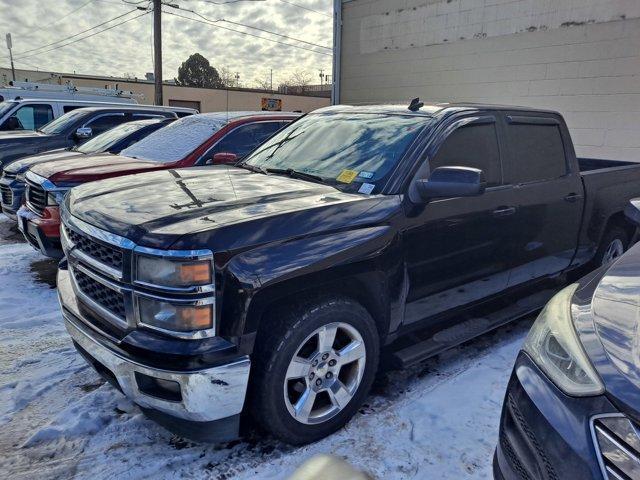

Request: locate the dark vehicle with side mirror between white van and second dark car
(0, 105), (186, 169)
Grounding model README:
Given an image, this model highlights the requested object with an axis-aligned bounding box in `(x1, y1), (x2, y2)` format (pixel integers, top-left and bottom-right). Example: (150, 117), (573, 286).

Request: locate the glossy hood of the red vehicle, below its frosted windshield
(31, 153), (169, 184)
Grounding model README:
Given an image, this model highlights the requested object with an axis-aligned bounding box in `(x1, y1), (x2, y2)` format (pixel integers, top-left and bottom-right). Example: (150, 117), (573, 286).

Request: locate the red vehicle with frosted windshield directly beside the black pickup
(18, 112), (300, 258)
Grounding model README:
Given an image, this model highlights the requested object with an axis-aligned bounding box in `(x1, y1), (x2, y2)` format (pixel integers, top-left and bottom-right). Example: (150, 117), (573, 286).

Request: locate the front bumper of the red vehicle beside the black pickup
(17, 205), (64, 258)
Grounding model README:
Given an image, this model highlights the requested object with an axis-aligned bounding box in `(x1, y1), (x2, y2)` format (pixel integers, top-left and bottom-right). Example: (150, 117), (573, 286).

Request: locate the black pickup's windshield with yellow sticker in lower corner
(243, 113), (431, 193)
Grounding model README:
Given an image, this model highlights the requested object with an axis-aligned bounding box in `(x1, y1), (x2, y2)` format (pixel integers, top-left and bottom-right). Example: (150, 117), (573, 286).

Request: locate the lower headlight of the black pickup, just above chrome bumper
(138, 297), (213, 332)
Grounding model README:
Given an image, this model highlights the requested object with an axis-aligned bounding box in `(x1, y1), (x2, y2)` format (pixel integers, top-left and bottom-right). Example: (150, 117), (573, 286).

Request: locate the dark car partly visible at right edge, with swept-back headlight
(493, 202), (640, 480)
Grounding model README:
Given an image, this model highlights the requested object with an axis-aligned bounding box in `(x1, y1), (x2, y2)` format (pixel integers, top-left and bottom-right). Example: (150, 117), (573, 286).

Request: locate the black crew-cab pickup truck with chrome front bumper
(58, 102), (640, 444)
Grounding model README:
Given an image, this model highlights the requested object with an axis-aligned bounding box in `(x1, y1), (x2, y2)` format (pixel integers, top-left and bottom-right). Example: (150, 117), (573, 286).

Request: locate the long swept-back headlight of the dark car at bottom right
(524, 284), (604, 396)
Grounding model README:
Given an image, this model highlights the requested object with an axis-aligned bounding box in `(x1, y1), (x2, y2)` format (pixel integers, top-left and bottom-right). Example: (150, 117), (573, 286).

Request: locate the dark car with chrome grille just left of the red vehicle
(0, 117), (175, 220)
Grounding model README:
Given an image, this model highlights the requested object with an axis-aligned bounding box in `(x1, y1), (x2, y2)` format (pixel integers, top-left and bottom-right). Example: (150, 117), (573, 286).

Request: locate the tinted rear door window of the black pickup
(506, 123), (567, 184)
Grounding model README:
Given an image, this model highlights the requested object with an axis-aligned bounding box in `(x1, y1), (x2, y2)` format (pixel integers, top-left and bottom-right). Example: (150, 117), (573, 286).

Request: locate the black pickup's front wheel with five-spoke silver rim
(250, 296), (380, 445)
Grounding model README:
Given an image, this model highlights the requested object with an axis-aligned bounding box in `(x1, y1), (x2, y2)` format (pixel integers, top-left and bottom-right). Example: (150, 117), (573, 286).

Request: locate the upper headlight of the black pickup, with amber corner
(136, 255), (213, 287)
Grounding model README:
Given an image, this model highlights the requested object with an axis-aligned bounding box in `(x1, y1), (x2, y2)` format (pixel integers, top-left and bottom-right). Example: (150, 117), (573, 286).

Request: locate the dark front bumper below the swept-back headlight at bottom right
(493, 352), (617, 480)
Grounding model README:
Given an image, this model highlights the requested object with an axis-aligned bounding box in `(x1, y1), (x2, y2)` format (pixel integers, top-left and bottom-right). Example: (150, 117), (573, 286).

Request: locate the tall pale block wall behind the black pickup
(340, 0), (640, 161)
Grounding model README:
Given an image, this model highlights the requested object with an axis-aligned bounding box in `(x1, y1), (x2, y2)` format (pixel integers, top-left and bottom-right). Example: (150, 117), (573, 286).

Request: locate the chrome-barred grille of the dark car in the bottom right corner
(593, 415), (640, 480)
